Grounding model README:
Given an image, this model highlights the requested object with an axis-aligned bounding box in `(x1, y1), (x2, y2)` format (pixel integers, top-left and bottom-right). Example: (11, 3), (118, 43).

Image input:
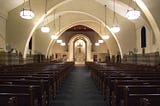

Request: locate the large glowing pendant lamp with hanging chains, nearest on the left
(20, 0), (35, 20)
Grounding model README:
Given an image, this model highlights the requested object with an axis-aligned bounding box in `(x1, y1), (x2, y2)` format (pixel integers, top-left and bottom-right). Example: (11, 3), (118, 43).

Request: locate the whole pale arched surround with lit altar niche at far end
(68, 34), (93, 64)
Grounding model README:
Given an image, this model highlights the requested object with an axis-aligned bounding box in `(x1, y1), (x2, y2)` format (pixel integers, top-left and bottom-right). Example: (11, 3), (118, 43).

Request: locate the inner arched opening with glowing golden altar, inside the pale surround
(73, 38), (87, 64)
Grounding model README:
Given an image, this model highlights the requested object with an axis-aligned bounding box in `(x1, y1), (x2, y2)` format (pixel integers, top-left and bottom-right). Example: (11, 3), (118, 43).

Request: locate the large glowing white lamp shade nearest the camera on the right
(126, 10), (141, 20)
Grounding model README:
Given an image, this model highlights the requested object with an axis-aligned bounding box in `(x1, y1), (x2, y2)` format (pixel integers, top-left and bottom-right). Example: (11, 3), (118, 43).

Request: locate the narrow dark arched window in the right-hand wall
(141, 26), (146, 48)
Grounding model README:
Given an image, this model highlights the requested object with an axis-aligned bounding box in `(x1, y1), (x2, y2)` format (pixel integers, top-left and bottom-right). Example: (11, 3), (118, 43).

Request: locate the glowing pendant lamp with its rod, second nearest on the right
(110, 0), (121, 33)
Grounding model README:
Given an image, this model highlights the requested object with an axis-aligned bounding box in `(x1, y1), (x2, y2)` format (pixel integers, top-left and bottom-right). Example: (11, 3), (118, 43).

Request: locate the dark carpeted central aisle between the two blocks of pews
(52, 66), (106, 106)
